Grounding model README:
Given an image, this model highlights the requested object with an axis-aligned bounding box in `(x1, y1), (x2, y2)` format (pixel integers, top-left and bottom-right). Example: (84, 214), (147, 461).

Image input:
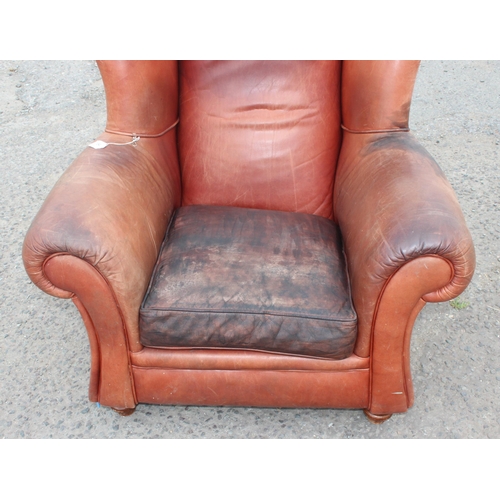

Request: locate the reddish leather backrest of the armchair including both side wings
(98, 61), (418, 218)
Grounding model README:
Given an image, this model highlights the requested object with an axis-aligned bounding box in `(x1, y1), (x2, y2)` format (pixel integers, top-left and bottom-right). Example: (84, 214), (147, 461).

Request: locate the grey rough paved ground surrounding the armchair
(0, 61), (500, 438)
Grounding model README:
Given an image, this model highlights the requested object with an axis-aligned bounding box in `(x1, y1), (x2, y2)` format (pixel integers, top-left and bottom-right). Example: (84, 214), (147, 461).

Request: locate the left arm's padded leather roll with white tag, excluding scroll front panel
(23, 130), (180, 348)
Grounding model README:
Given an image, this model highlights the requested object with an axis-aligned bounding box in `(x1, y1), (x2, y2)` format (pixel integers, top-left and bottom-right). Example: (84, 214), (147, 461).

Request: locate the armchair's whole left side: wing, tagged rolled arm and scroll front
(23, 61), (181, 408)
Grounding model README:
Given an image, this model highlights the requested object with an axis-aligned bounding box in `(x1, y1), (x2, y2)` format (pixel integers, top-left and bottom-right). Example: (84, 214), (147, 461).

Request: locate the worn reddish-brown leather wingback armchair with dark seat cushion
(23, 61), (475, 421)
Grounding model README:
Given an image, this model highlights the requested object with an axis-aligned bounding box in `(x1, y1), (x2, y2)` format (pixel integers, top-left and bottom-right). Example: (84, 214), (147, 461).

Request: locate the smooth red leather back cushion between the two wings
(178, 61), (341, 219)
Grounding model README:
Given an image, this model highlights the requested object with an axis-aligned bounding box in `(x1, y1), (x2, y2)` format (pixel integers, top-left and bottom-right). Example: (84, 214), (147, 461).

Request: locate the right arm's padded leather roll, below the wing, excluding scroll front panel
(334, 131), (475, 352)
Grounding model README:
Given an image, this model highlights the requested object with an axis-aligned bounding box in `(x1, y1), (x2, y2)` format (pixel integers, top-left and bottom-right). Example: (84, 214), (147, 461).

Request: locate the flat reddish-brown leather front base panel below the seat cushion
(132, 366), (369, 409)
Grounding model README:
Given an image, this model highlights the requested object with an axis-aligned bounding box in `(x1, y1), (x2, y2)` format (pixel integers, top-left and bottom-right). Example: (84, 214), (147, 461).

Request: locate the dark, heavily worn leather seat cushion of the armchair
(140, 205), (356, 359)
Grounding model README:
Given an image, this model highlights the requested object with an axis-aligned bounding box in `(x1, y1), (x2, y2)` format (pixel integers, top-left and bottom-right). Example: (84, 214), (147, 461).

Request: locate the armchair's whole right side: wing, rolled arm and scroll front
(334, 61), (475, 414)
